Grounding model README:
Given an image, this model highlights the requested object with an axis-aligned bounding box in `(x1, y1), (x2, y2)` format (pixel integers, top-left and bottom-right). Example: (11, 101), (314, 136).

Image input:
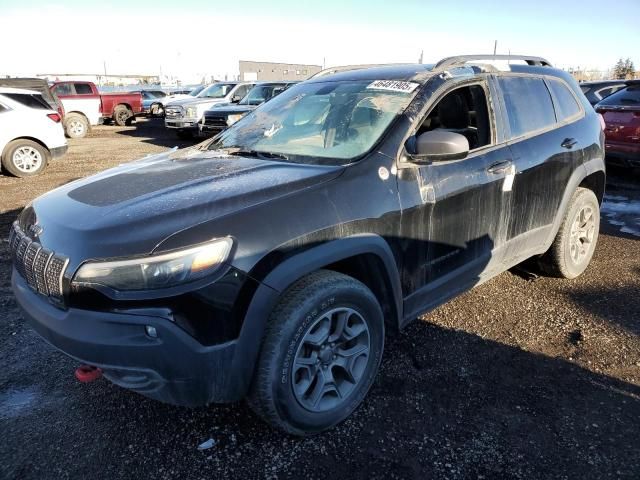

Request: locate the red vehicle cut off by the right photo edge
(595, 80), (640, 168)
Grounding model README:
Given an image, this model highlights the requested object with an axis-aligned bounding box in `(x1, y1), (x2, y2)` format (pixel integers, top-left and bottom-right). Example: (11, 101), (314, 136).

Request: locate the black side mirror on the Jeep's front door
(406, 130), (469, 164)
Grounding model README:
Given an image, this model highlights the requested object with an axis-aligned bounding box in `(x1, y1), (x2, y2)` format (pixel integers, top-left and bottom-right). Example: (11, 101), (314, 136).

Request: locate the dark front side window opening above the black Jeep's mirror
(417, 85), (492, 151)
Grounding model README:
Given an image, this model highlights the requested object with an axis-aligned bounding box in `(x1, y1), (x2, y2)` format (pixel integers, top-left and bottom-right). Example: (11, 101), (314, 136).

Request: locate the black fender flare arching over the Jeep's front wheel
(231, 234), (402, 400)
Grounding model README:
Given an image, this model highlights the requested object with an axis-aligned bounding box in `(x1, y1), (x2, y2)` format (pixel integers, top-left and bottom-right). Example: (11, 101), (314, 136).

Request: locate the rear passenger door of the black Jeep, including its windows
(497, 75), (587, 263)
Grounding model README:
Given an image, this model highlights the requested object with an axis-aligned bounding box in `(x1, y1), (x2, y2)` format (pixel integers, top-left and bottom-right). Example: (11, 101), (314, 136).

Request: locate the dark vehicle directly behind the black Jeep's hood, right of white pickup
(199, 82), (297, 135)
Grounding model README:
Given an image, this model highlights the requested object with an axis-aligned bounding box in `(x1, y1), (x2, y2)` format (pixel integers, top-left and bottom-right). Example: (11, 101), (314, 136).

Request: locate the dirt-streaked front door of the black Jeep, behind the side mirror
(398, 80), (511, 317)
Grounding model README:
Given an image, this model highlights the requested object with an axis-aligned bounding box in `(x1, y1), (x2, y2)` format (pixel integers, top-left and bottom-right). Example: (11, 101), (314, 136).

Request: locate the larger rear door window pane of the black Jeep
(498, 77), (556, 138)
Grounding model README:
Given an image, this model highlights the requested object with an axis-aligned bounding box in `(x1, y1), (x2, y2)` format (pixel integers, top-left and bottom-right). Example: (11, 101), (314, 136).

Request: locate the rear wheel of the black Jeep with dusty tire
(538, 188), (600, 278)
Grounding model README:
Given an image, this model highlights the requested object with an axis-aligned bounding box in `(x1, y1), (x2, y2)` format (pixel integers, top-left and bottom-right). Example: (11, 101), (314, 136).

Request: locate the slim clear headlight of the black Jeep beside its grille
(73, 238), (233, 290)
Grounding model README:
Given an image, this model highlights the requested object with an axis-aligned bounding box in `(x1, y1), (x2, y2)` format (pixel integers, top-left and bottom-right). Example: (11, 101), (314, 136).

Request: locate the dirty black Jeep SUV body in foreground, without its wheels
(11, 58), (604, 434)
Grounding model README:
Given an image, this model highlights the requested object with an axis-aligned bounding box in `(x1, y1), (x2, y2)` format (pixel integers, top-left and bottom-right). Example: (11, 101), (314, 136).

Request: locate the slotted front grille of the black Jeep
(9, 222), (69, 302)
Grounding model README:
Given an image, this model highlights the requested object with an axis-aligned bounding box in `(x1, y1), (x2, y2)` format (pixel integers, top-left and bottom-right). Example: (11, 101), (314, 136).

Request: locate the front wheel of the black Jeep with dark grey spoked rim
(249, 270), (384, 435)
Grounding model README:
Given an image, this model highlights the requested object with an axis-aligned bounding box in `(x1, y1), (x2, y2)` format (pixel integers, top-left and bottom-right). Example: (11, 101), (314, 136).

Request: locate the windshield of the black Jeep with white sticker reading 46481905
(208, 80), (418, 165)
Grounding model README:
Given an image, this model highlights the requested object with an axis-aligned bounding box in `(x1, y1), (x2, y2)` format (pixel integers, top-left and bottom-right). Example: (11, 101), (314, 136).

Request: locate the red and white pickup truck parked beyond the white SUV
(51, 81), (142, 138)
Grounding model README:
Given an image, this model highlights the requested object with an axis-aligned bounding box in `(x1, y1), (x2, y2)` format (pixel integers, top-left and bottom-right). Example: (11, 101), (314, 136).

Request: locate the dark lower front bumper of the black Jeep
(11, 269), (242, 406)
